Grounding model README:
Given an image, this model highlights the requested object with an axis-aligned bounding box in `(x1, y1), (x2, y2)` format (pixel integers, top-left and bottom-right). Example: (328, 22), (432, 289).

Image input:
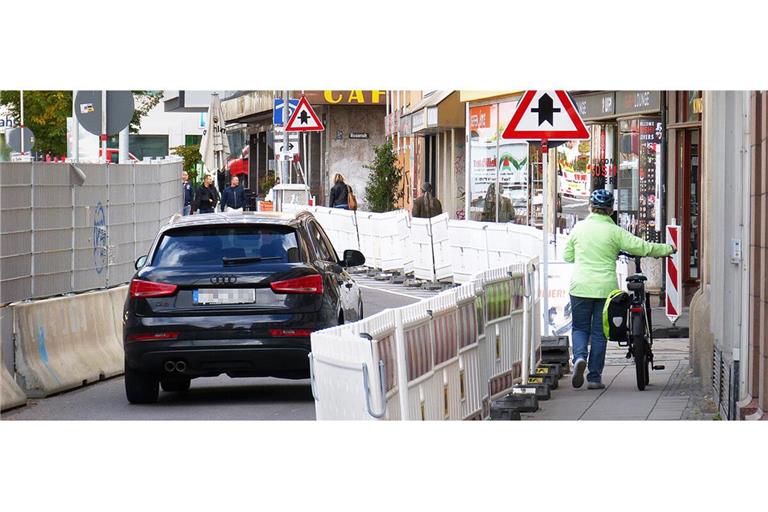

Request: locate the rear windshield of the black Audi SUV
(152, 225), (301, 267)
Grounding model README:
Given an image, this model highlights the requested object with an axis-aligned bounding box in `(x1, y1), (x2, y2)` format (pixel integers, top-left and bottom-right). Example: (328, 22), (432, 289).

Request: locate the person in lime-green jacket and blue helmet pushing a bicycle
(564, 189), (673, 389)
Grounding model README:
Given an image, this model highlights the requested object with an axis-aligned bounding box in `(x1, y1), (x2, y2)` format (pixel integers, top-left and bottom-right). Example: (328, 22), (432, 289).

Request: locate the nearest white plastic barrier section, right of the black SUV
(310, 258), (540, 420)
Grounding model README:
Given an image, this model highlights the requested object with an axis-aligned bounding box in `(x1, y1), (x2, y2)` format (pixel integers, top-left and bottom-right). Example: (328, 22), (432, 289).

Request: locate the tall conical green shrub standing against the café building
(365, 141), (403, 213)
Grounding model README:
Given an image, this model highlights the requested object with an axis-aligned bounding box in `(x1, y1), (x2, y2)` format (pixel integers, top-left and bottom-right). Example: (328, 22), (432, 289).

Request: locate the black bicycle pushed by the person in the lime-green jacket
(619, 251), (665, 391)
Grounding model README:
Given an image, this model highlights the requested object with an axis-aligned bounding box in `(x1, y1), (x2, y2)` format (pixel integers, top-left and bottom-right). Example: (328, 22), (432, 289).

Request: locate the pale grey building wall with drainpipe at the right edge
(690, 91), (768, 419)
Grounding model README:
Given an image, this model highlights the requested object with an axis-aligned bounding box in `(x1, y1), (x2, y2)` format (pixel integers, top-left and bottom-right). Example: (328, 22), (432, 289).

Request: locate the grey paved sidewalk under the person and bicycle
(521, 338), (712, 420)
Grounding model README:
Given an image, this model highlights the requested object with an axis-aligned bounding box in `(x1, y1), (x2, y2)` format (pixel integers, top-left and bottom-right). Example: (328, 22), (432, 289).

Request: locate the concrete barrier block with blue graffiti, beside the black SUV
(13, 290), (123, 398)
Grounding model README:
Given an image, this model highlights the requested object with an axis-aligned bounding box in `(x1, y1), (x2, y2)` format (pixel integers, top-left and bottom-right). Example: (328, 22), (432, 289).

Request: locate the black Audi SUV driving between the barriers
(123, 212), (365, 403)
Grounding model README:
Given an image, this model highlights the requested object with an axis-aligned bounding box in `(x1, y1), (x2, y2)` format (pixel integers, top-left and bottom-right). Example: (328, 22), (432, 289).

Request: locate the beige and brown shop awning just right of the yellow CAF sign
(408, 91), (464, 135)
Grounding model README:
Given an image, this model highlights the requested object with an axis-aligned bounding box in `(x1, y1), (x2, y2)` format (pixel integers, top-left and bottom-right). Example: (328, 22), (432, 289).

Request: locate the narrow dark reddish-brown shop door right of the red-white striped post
(677, 129), (701, 306)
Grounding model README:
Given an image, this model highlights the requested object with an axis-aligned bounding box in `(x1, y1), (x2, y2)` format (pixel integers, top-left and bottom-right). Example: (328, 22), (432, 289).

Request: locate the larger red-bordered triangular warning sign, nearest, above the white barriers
(501, 91), (589, 140)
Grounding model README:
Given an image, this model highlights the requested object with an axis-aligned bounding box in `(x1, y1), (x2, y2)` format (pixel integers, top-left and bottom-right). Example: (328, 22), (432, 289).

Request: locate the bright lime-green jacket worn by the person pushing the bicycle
(564, 213), (673, 299)
